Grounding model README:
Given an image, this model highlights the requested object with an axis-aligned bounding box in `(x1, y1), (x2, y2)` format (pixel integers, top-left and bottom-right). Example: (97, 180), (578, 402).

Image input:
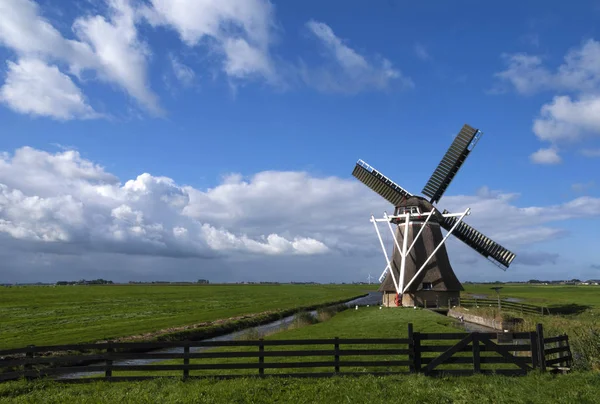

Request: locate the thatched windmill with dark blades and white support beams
(352, 124), (515, 306)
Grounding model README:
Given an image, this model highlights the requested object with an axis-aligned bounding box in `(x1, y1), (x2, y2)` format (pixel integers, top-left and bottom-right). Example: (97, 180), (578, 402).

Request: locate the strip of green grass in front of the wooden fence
(0, 373), (600, 404)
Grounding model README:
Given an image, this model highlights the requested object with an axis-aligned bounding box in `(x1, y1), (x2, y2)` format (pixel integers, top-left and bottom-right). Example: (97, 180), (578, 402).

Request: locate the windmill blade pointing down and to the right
(440, 210), (516, 270)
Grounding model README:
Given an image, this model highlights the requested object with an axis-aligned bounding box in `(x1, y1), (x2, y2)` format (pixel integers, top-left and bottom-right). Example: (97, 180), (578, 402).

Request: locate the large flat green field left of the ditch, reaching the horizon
(0, 285), (374, 349)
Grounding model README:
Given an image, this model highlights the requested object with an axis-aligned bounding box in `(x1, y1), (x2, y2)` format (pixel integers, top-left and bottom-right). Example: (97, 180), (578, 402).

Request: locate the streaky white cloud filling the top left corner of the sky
(0, 0), (162, 117)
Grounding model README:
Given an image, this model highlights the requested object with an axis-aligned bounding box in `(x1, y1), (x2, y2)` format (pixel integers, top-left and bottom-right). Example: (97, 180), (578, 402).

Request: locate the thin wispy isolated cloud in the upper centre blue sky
(301, 20), (414, 94)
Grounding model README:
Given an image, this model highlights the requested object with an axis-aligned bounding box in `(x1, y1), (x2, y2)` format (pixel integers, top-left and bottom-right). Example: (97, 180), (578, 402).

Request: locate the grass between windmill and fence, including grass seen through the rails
(103, 307), (517, 377)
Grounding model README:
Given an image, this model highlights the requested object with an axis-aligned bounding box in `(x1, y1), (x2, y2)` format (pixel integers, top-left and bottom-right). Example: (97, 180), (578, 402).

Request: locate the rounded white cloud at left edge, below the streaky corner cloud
(0, 59), (100, 120)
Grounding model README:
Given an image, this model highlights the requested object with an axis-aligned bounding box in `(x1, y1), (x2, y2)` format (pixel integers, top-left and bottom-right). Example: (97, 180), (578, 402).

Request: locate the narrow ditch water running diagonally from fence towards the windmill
(57, 292), (381, 379)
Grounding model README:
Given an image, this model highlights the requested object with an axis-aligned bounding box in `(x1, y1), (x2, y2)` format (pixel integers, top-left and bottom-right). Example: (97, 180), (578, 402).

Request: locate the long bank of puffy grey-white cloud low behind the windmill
(0, 147), (600, 280)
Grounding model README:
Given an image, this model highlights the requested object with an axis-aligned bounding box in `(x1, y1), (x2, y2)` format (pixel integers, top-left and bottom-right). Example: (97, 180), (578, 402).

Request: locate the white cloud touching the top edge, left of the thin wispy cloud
(140, 0), (278, 82)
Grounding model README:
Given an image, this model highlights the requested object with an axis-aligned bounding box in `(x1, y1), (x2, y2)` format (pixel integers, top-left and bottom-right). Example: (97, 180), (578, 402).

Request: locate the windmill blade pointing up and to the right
(421, 124), (483, 203)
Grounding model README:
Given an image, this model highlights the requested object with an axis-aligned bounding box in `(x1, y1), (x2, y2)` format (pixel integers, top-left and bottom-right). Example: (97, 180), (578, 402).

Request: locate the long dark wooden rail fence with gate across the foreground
(0, 324), (571, 382)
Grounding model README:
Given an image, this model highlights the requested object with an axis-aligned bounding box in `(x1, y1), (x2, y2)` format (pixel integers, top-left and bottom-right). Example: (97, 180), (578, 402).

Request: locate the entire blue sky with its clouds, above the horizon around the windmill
(0, 0), (600, 281)
